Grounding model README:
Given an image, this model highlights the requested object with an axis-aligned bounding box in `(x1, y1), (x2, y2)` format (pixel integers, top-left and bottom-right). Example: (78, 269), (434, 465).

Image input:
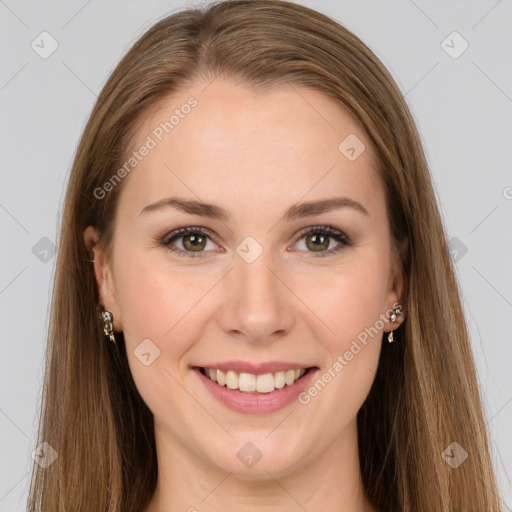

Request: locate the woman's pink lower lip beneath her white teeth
(193, 368), (319, 414)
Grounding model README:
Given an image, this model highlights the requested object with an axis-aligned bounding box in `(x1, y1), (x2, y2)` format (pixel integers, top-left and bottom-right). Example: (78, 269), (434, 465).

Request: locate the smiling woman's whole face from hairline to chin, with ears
(85, 79), (402, 479)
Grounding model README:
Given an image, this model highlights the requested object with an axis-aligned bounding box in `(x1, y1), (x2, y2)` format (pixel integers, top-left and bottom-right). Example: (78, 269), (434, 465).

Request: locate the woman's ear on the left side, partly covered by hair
(84, 226), (122, 332)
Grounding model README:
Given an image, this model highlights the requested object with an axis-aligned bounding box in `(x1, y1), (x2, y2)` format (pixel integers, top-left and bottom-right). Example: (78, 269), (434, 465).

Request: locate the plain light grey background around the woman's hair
(0, 0), (512, 512)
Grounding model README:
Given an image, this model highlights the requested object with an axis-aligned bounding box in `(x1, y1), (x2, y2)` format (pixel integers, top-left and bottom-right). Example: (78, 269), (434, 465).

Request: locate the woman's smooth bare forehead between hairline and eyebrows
(120, 79), (382, 220)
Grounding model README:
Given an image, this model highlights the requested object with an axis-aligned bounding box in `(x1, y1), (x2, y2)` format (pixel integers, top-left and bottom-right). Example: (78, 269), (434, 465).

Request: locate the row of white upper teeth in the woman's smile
(202, 368), (306, 393)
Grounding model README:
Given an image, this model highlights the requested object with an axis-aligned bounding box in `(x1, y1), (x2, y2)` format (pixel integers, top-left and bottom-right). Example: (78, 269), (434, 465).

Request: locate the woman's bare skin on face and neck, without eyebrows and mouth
(84, 78), (403, 512)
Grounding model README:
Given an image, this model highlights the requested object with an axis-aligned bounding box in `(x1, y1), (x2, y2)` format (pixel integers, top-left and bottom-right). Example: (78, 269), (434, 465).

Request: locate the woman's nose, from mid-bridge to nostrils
(217, 251), (294, 343)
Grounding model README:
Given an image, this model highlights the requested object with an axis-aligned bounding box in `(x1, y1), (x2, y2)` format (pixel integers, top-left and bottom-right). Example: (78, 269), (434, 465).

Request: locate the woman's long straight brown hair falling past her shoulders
(28, 0), (501, 512)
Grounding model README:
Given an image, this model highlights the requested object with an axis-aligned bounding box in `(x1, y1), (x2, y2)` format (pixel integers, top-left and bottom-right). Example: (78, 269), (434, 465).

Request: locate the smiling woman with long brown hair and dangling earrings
(29, 0), (500, 512)
